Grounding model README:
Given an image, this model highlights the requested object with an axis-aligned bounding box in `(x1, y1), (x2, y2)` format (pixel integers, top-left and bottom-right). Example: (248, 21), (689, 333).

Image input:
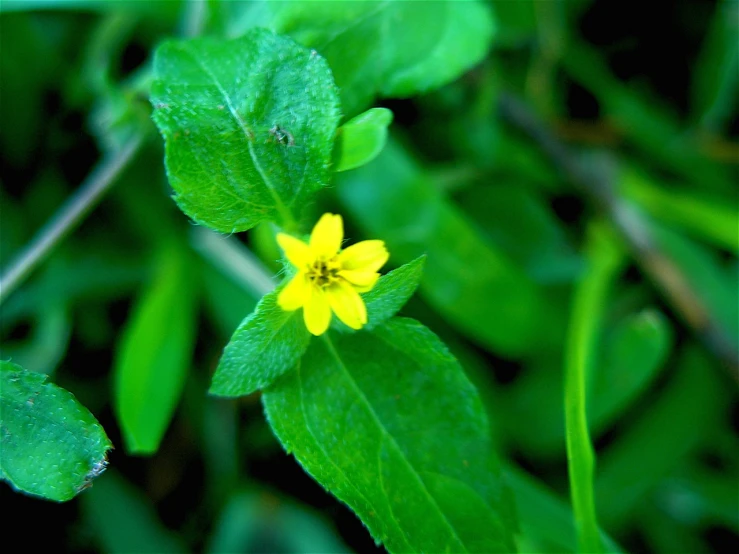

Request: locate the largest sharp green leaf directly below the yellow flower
(262, 318), (514, 552)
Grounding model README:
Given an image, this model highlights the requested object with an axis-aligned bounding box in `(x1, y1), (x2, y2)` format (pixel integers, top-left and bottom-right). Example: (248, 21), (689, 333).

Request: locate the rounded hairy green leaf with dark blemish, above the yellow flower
(151, 29), (340, 233)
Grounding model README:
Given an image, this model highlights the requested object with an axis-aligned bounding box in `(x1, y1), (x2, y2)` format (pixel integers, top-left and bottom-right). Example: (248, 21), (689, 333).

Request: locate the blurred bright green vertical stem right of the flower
(564, 221), (621, 553)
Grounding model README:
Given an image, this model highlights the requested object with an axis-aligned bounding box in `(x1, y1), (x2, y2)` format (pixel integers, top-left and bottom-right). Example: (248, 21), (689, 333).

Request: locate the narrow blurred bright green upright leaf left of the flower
(114, 244), (196, 454)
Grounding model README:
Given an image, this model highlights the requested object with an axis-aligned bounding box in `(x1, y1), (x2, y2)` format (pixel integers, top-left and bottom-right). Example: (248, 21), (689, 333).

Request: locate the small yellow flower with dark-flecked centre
(277, 214), (389, 336)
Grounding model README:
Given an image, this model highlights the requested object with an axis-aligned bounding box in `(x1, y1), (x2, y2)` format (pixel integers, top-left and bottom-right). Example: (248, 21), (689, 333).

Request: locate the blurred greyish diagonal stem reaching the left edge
(0, 136), (142, 303)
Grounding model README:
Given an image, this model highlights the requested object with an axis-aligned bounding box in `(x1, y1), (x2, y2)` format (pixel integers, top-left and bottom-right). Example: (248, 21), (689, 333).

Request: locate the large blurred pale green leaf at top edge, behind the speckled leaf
(230, 0), (494, 114)
